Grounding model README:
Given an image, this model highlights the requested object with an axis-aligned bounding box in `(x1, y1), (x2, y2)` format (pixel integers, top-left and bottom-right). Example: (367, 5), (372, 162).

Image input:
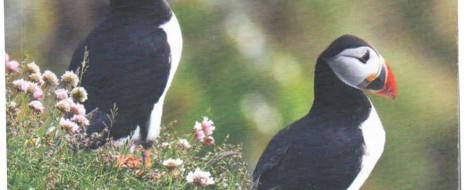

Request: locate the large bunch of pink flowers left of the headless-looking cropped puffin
(5, 54), (90, 132)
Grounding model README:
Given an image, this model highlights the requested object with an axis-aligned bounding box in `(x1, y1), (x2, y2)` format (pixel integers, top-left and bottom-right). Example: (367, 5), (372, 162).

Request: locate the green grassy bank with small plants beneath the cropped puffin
(6, 54), (251, 189)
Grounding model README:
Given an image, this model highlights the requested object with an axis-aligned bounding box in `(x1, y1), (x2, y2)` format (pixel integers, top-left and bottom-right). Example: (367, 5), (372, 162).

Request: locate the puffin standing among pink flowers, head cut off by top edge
(68, 0), (182, 169)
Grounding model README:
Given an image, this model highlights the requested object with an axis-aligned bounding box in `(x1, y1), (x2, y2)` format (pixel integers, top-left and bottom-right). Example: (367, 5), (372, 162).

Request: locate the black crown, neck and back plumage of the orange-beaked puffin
(253, 35), (371, 190)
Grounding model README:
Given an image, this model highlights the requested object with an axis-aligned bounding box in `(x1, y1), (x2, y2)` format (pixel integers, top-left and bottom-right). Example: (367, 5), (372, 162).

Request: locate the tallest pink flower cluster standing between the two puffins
(194, 117), (215, 145)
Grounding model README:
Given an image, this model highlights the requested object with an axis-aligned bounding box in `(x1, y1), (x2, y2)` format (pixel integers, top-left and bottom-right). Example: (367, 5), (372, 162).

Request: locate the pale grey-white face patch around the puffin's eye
(328, 46), (384, 88)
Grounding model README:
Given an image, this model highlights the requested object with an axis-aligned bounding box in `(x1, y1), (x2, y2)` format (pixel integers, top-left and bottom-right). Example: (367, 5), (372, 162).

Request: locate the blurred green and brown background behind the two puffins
(5, 0), (458, 190)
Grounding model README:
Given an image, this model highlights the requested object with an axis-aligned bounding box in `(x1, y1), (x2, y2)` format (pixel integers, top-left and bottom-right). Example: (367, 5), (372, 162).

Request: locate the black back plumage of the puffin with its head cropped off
(68, 0), (172, 142)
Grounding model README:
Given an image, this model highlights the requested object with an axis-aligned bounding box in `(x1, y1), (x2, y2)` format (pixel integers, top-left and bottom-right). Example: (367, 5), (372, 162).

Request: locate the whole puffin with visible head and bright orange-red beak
(253, 35), (397, 190)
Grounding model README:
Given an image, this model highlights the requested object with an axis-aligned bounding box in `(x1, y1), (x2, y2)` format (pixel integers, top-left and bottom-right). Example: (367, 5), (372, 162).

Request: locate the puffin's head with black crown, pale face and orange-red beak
(320, 35), (397, 98)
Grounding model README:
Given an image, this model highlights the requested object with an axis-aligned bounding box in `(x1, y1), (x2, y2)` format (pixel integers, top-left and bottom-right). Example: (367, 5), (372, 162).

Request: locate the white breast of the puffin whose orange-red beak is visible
(348, 101), (386, 190)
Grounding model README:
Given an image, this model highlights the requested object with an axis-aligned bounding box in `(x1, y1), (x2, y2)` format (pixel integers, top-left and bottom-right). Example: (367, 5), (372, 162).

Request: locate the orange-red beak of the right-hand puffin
(365, 61), (397, 99)
